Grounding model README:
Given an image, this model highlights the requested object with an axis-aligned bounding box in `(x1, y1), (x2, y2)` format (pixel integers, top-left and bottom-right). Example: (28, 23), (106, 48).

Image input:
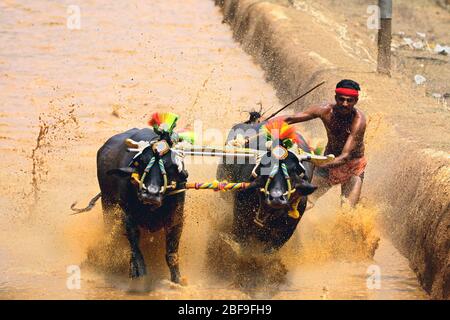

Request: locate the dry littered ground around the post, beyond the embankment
(289, 0), (450, 104)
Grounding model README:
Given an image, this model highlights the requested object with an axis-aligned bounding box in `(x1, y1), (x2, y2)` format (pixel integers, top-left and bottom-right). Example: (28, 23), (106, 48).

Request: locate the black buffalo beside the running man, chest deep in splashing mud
(217, 121), (316, 253)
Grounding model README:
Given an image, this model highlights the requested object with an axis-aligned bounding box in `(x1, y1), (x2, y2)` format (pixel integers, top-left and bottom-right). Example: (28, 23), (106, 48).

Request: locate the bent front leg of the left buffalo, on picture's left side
(125, 215), (147, 278)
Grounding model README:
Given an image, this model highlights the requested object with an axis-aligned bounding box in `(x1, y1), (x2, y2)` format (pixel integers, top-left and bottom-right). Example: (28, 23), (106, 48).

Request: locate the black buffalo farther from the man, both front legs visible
(75, 128), (188, 283)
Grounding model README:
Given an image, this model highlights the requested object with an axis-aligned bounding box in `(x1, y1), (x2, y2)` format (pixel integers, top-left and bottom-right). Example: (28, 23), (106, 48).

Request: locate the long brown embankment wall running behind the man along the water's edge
(215, 0), (450, 299)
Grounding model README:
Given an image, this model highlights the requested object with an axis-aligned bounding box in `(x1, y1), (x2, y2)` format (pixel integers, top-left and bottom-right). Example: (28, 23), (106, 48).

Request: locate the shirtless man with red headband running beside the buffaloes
(285, 80), (367, 207)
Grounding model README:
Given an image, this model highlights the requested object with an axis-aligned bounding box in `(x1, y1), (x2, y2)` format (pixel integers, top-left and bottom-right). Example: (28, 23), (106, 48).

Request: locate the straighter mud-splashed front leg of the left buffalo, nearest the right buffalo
(165, 223), (183, 283)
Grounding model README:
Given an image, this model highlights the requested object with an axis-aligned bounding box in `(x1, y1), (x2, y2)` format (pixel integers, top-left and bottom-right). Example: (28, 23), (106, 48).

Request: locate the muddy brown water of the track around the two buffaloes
(0, 0), (427, 299)
